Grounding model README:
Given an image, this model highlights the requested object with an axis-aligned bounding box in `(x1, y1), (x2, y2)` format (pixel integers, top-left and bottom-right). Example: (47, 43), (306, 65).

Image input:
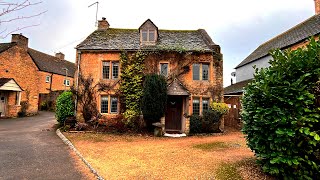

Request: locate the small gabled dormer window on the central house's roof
(139, 19), (158, 45)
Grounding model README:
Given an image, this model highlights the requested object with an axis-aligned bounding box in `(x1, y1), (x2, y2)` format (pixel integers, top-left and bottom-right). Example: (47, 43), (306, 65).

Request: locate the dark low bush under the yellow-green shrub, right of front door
(202, 109), (222, 133)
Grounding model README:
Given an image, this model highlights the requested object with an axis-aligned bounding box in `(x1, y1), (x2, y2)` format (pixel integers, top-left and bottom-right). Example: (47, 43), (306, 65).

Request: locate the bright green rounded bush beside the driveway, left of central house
(56, 91), (74, 126)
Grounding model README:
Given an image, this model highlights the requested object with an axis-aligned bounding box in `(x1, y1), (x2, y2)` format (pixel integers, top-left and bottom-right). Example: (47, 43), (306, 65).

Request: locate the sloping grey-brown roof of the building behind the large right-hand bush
(235, 14), (320, 69)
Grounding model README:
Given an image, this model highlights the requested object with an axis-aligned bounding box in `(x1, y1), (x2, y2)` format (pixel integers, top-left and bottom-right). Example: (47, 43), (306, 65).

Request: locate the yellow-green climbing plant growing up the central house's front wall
(120, 51), (145, 126)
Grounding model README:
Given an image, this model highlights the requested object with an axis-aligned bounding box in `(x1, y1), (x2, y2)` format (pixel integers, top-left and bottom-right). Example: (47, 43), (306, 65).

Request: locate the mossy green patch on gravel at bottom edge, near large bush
(216, 163), (242, 180)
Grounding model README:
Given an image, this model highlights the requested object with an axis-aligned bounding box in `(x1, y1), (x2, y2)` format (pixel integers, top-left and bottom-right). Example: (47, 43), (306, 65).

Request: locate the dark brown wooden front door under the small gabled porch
(165, 96), (182, 131)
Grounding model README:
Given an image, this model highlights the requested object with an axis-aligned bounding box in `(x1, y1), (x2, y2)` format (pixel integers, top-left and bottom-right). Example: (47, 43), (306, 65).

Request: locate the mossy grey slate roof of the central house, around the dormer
(76, 28), (215, 52)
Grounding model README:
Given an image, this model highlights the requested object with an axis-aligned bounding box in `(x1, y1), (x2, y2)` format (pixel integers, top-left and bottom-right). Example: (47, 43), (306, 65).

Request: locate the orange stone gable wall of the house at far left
(0, 46), (39, 117)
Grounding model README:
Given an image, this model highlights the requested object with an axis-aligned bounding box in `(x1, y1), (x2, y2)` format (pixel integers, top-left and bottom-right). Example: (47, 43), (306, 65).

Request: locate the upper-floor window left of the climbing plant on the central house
(102, 61), (119, 79)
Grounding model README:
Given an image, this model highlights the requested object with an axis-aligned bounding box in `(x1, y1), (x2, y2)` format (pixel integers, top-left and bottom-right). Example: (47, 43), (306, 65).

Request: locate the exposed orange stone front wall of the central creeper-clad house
(75, 52), (223, 121)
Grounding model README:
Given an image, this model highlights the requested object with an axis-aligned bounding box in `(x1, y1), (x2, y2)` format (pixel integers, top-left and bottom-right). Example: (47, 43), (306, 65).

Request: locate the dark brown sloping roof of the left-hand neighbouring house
(28, 48), (76, 77)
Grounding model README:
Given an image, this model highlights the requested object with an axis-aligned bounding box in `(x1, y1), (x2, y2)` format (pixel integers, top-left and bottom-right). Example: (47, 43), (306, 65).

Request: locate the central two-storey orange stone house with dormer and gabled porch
(75, 18), (223, 133)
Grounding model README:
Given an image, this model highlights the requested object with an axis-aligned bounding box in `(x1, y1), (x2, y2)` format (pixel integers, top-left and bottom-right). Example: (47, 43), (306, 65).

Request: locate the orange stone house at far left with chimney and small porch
(0, 34), (75, 117)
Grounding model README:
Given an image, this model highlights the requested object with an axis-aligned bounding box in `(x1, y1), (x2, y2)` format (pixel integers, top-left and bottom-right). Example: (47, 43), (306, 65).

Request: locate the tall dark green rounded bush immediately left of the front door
(142, 74), (167, 126)
